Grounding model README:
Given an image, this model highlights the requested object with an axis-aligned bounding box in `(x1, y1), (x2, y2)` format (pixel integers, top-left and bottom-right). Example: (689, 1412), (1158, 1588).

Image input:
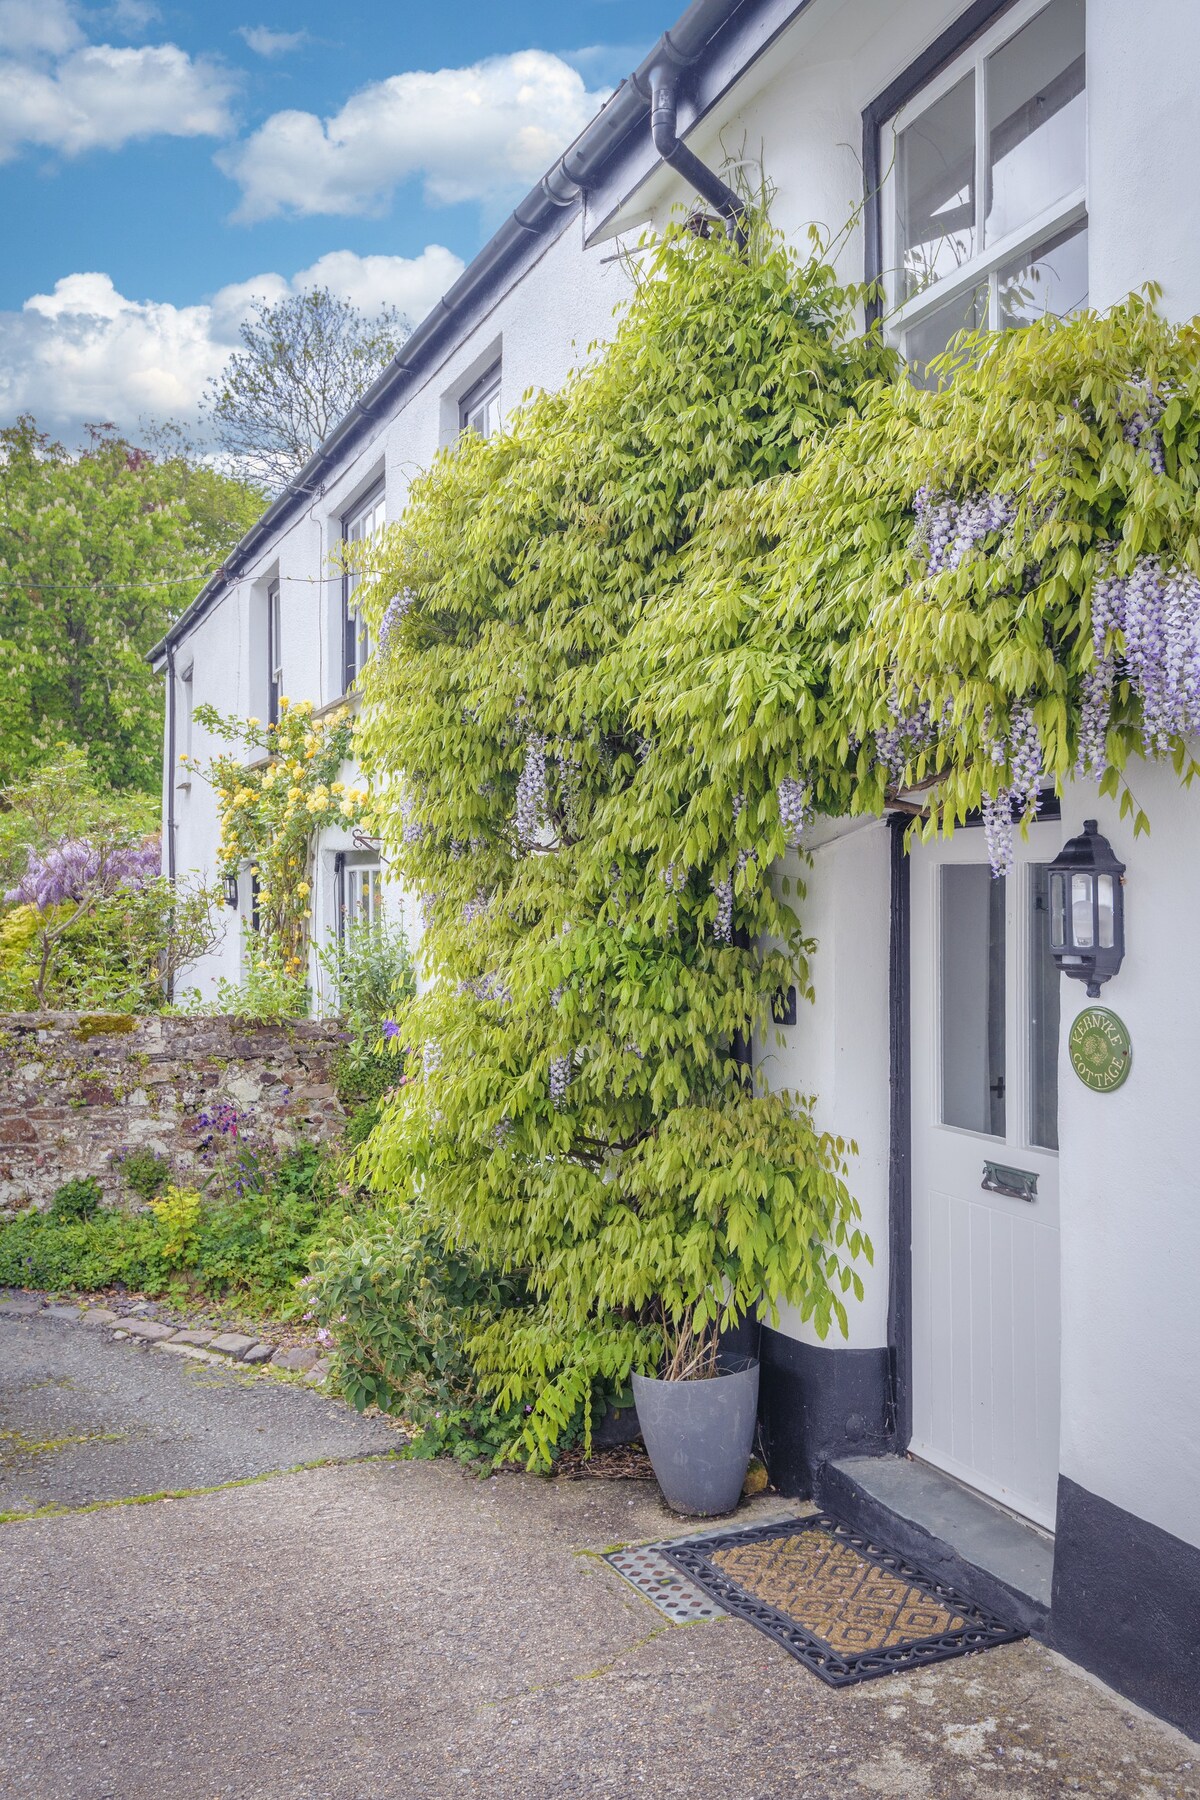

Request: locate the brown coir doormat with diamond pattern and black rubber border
(662, 1512), (1024, 1687)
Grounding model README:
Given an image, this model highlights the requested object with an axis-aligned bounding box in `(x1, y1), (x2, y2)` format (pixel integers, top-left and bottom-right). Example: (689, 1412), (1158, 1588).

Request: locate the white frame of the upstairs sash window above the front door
(880, 0), (1087, 352)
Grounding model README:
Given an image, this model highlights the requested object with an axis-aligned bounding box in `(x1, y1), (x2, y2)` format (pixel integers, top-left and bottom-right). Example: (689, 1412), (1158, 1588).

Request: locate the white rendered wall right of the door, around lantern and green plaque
(1058, 763), (1200, 1544)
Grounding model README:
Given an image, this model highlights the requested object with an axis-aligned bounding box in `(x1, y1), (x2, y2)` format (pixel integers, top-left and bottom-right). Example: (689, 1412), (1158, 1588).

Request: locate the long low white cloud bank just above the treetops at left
(0, 245), (462, 441)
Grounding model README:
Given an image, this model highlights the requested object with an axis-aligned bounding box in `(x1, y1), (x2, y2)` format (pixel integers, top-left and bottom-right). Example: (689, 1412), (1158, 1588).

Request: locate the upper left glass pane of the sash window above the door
(896, 72), (975, 301)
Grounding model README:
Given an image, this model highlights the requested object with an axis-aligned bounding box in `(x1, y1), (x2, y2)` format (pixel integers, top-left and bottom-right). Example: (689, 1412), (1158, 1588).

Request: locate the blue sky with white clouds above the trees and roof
(0, 0), (682, 439)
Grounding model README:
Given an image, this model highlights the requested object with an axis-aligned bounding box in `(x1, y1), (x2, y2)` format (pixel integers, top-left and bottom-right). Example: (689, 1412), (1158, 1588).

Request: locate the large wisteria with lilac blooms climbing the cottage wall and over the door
(347, 207), (1200, 1460)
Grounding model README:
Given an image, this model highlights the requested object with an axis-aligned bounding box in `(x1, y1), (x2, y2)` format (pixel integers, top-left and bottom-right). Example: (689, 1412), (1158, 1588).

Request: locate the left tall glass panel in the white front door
(941, 864), (1006, 1138)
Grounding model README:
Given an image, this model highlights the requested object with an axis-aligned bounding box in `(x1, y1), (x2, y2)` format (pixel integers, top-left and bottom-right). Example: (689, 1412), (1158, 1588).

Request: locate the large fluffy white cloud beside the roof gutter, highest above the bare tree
(218, 50), (604, 220)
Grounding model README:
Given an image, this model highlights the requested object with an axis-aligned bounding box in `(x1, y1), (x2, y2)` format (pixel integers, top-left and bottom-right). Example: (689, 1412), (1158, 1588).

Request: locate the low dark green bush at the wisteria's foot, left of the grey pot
(304, 1201), (513, 1462)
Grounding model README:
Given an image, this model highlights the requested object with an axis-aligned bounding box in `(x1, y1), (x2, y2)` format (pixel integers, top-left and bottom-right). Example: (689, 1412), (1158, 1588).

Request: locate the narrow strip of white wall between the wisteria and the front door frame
(754, 819), (891, 1350)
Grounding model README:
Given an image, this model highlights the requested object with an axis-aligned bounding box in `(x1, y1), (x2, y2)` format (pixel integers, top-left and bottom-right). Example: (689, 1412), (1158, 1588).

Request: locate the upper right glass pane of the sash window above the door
(986, 0), (1087, 243)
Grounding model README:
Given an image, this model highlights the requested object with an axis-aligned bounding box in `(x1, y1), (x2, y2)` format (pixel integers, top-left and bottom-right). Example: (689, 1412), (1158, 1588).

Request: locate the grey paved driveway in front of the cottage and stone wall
(0, 1318), (1200, 1800)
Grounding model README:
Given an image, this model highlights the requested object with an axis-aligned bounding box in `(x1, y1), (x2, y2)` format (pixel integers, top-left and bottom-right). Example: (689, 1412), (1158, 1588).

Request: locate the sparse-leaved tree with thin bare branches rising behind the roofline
(205, 288), (410, 490)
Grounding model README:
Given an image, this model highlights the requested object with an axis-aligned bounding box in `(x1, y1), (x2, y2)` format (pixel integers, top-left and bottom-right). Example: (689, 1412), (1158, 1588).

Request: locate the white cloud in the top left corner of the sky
(0, 0), (236, 162)
